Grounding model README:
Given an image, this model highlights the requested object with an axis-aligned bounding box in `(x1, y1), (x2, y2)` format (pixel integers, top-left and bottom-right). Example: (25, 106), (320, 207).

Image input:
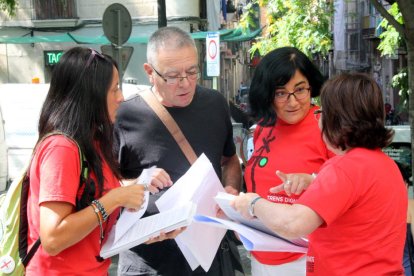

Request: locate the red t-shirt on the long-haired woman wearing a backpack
(26, 135), (120, 276)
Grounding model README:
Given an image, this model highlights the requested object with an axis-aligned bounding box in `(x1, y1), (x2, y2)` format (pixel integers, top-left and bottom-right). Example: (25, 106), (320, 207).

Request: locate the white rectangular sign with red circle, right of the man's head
(206, 32), (220, 77)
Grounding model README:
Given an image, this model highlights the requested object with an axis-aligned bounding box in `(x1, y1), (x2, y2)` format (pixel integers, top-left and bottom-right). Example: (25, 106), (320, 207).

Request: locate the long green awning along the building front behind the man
(0, 28), (262, 45)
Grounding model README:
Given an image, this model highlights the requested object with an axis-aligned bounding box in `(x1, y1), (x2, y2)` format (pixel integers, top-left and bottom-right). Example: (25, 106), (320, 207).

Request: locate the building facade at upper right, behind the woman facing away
(331, 0), (408, 123)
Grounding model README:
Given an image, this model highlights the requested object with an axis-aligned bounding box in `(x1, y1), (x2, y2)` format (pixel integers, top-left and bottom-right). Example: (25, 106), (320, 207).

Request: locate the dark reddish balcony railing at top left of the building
(33, 0), (77, 20)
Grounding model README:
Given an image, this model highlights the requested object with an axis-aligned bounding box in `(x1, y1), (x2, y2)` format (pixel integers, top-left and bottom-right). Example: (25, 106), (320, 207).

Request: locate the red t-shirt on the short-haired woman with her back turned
(296, 148), (408, 276)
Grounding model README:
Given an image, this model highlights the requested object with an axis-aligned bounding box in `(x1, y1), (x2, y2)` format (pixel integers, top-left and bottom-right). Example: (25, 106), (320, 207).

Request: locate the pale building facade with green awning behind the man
(0, 0), (257, 102)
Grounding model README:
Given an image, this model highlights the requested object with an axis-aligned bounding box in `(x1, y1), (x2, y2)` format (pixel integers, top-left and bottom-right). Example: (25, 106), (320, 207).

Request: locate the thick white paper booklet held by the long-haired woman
(100, 202), (196, 258)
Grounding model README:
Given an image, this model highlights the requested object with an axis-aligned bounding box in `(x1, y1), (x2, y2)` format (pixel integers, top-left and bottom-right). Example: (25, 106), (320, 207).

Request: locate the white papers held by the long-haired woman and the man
(100, 154), (227, 271)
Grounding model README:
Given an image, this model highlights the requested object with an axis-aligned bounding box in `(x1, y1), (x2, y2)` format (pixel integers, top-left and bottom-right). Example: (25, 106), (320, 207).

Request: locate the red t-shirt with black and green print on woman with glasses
(244, 106), (333, 265)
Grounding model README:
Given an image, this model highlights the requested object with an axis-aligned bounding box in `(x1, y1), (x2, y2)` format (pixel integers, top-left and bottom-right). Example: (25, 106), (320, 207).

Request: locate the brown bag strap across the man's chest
(140, 89), (197, 165)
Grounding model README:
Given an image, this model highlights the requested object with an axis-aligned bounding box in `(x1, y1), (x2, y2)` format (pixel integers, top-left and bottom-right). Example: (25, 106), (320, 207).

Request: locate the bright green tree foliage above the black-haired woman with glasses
(241, 0), (333, 56)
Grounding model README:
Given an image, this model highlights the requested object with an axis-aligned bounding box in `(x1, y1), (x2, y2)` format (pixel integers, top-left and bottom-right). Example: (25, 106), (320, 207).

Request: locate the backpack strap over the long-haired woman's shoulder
(19, 131), (88, 267)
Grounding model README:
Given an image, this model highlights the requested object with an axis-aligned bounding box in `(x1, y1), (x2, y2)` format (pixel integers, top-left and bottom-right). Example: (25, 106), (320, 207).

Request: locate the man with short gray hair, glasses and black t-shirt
(115, 27), (242, 275)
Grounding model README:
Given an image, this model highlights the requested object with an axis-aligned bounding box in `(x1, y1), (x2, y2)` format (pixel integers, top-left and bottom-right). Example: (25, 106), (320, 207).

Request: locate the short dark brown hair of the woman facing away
(320, 73), (394, 150)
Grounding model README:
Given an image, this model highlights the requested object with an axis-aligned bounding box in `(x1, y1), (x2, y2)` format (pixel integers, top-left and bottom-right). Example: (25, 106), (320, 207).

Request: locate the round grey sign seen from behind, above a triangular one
(102, 3), (132, 46)
